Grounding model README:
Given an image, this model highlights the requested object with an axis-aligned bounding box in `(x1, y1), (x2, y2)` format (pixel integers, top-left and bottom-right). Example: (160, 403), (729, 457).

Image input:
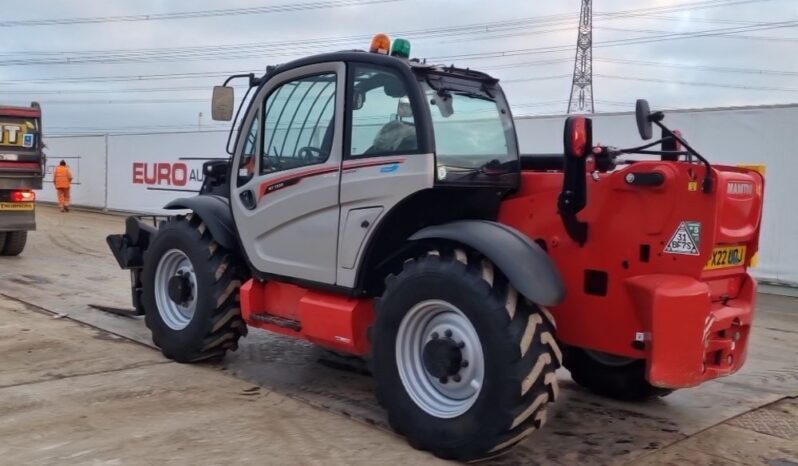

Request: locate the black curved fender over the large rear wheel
(410, 220), (565, 306)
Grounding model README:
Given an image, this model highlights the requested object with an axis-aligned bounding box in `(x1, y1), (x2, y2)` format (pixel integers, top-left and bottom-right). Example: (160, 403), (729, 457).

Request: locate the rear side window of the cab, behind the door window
(348, 65), (418, 157)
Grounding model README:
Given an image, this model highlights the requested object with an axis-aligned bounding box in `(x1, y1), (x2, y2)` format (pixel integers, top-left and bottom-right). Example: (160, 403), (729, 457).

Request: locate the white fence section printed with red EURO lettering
(108, 132), (227, 213)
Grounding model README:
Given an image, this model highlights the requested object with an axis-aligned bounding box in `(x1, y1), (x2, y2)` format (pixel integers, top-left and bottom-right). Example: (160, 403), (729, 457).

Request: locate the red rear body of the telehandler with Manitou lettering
(499, 162), (764, 388)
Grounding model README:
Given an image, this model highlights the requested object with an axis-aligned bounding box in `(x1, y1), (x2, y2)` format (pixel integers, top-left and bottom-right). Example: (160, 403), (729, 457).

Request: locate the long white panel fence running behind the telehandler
(40, 105), (798, 285)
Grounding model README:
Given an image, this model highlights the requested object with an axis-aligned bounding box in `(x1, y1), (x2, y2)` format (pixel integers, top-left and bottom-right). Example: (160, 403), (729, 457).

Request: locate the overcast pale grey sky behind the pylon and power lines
(0, 0), (798, 135)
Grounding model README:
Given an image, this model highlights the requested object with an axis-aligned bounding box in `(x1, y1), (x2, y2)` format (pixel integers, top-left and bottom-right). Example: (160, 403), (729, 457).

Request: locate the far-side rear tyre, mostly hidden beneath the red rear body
(564, 346), (673, 401)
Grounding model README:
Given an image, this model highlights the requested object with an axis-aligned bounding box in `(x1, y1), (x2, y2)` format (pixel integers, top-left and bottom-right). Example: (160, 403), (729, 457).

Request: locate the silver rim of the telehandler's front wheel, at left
(155, 249), (197, 330)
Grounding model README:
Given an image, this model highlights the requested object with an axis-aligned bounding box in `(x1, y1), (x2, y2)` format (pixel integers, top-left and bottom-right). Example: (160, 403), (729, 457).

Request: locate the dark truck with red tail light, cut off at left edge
(0, 102), (45, 256)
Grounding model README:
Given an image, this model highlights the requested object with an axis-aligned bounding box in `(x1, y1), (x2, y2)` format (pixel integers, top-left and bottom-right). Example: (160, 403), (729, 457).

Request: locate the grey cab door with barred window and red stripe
(230, 62), (346, 284)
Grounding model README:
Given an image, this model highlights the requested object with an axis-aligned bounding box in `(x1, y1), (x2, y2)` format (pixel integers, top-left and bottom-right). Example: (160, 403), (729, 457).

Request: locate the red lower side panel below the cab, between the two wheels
(241, 279), (374, 355)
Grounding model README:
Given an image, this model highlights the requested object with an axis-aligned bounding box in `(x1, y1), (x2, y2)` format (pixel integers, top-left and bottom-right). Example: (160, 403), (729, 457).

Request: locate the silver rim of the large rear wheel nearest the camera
(396, 300), (485, 419)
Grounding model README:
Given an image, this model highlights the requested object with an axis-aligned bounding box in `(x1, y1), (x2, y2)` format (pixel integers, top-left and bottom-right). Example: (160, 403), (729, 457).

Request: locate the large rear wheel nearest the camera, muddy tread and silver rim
(372, 250), (561, 461)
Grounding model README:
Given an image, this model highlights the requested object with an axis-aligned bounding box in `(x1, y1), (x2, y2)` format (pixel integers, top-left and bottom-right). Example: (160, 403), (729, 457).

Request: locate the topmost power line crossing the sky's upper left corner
(0, 0), (400, 28)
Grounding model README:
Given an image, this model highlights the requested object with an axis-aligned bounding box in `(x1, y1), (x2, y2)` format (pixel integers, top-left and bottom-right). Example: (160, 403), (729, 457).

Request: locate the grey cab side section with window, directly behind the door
(336, 62), (435, 287)
